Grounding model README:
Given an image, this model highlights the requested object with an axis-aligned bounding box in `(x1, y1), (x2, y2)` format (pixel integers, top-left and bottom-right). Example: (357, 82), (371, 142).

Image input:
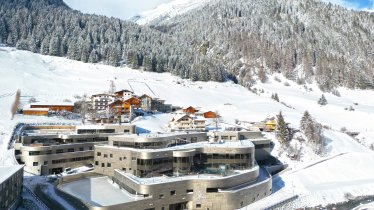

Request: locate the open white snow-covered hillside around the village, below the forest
(0, 47), (374, 207)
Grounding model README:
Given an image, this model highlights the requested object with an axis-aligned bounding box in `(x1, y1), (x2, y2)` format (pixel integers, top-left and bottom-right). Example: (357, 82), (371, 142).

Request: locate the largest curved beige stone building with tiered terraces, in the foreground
(93, 131), (272, 210)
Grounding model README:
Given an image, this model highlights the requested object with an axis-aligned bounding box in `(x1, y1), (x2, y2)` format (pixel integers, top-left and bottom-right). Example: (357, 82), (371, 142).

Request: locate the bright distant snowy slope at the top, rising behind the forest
(131, 0), (211, 25)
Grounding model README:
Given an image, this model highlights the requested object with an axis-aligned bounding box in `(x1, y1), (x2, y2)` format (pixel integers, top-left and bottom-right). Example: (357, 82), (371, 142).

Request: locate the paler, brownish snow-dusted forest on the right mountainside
(151, 0), (374, 91)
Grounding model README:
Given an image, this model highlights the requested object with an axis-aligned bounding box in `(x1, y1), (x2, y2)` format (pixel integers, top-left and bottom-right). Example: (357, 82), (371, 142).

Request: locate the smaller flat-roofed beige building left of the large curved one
(14, 124), (135, 175)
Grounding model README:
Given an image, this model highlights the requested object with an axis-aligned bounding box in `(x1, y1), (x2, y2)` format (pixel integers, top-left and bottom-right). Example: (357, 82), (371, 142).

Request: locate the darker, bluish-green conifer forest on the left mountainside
(0, 0), (228, 81)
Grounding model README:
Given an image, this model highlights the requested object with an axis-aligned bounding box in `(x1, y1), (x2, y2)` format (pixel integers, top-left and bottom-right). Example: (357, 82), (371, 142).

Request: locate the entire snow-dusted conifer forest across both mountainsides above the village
(0, 0), (374, 91)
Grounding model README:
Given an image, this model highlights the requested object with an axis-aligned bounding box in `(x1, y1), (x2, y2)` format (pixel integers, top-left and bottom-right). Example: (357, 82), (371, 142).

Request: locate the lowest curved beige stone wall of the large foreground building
(62, 168), (272, 210)
